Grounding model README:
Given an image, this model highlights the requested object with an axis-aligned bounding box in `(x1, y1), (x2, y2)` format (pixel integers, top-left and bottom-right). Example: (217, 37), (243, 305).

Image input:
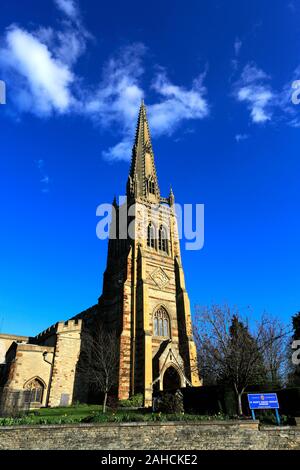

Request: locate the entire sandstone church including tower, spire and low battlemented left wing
(0, 102), (201, 407)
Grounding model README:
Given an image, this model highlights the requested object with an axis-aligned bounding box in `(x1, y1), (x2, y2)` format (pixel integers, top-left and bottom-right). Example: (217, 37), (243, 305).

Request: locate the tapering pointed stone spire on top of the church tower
(127, 100), (160, 202)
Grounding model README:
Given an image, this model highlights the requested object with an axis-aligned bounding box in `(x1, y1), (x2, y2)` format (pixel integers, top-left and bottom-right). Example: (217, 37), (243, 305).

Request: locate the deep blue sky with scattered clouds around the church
(0, 0), (300, 335)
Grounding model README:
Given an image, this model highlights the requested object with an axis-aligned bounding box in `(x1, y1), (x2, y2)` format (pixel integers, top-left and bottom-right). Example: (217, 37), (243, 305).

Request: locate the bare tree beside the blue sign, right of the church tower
(195, 305), (288, 415)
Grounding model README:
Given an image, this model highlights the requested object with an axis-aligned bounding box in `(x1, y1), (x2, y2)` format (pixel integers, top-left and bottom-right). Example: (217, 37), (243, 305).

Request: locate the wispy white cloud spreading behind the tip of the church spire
(84, 44), (209, 161)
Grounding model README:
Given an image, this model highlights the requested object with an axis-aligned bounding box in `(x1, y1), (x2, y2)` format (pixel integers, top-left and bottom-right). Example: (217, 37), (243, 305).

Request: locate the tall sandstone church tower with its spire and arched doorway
(99, 103), (200, 406)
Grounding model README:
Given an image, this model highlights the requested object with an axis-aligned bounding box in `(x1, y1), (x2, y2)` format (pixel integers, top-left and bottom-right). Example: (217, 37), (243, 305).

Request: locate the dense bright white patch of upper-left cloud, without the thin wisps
(0, 26), (74, 115)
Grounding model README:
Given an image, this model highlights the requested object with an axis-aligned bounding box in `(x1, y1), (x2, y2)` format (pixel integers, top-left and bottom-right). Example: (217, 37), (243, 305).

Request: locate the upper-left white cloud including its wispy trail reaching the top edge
(0, 0), (91, 117)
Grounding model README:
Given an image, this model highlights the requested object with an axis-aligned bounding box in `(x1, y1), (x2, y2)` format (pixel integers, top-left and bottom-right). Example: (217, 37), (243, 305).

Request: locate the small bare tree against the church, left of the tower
(79, 321), (120, 413)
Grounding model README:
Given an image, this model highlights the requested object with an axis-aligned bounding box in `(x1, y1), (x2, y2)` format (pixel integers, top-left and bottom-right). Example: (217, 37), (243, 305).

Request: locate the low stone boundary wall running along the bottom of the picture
(0, 421), (300, 451)
